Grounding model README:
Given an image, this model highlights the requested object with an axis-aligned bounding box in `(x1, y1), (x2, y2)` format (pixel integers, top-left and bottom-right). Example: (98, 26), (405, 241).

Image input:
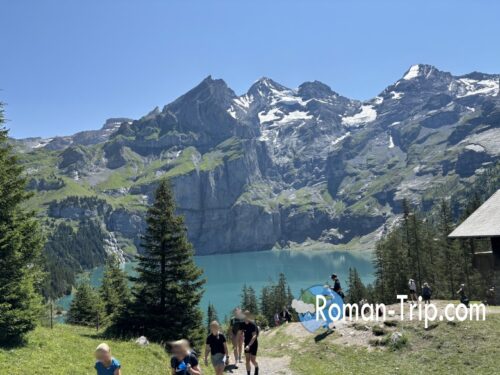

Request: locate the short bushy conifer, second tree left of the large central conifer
(67, 277), (104, 326)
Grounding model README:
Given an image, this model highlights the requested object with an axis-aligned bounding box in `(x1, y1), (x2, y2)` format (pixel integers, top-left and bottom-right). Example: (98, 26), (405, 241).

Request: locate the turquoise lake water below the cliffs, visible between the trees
(59, 250), (374, 319)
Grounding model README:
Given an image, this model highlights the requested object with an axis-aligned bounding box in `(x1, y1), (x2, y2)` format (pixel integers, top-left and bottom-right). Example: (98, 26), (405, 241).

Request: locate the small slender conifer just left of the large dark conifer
(99, 255), (130, 321)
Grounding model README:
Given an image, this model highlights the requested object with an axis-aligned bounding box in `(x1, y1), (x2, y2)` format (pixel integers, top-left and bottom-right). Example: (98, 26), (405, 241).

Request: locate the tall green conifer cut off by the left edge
(0, 103), (43, 345)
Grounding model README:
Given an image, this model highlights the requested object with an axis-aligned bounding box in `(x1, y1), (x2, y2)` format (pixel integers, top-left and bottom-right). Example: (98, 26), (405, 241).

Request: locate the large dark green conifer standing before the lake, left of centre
(118, 180), (205, 347)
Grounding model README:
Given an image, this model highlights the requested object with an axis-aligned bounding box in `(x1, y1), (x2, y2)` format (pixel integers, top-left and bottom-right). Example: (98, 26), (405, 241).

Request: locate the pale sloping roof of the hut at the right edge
(448, 190), (500, 238)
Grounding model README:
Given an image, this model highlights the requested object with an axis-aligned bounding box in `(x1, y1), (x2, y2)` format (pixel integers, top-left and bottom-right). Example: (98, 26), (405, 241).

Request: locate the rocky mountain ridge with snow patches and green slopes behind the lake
(16, 64), (500, 254)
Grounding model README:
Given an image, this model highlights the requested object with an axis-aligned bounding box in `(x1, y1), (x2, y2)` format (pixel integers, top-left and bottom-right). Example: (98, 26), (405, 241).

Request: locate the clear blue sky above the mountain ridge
(0, 0), (500, 138)
